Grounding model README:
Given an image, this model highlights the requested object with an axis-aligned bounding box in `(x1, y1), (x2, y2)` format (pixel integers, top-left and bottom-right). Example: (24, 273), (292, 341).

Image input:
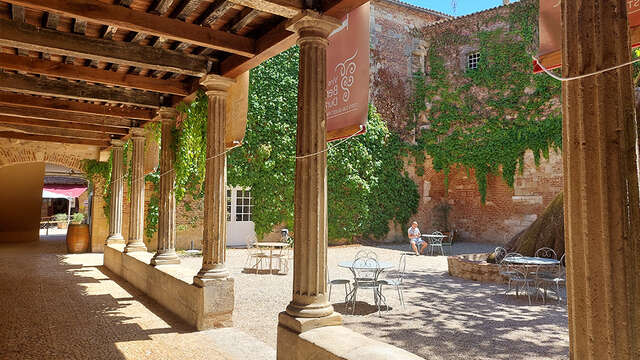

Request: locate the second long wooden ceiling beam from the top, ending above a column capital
(0, 19), (210, 77)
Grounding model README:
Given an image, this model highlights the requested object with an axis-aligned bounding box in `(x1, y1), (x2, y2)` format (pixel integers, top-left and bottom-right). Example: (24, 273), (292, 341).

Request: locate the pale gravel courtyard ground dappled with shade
(182, 243), (569, 359)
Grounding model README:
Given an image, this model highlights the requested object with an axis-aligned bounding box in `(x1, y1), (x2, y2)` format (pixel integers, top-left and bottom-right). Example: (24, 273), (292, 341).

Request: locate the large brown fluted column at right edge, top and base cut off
(562, 0), (640, 360)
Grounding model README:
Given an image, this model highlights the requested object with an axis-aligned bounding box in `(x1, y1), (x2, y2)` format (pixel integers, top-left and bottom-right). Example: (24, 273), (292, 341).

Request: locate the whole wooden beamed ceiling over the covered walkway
(0, 0), (366, 147)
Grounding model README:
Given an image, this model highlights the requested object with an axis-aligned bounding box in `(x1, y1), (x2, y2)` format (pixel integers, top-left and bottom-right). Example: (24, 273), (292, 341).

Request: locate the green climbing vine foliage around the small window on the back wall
(410, 0), (562, 203)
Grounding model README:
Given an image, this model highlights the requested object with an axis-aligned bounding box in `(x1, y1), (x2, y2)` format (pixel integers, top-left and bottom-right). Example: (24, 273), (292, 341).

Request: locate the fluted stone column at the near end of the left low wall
(193, 75), (234, 287)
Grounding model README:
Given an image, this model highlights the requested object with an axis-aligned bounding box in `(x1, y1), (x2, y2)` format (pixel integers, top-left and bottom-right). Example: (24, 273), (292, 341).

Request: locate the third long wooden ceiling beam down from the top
(0, 54), (190, 96)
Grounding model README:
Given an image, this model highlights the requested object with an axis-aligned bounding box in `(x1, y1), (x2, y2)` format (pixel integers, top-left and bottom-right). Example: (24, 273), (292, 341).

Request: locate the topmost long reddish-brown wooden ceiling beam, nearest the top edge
(6, 0), (255, 57)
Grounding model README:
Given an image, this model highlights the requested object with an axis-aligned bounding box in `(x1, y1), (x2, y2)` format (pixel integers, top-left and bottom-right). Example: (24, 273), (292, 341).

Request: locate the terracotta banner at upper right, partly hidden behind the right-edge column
(533, 0), (640, 73)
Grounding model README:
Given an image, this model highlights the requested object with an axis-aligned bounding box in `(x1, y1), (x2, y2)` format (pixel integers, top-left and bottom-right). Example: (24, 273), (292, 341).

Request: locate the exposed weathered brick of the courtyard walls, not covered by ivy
(371, 0), (562, 244)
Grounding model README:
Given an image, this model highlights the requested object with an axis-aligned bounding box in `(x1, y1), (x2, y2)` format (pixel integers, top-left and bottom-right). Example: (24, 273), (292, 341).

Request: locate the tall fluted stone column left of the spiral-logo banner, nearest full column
(278, 11), (342, 336)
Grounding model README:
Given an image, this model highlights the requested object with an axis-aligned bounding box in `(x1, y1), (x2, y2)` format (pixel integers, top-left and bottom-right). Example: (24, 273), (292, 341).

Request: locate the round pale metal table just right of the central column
(338, 260), (393, 313)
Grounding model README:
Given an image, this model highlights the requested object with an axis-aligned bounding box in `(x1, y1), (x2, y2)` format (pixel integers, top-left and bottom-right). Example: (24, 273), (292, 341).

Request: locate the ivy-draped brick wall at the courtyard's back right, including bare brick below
(396, 0), (562, 243)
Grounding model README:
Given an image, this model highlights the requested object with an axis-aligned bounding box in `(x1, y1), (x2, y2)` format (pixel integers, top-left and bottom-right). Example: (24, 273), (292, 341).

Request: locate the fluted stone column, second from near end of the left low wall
(151, 108), (180, 265)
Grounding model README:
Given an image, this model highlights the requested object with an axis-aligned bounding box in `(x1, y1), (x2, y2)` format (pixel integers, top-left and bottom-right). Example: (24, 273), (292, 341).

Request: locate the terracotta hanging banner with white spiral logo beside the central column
(326, 3), (369, 141)
